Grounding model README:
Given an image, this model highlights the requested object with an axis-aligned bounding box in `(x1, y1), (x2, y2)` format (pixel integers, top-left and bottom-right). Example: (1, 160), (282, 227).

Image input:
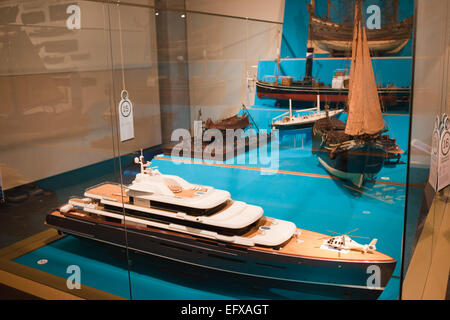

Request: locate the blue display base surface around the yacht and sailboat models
(16, 109), (409, 299)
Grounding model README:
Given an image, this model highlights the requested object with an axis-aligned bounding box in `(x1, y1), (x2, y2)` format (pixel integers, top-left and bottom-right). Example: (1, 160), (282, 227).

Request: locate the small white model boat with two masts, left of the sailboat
(272, 96), (344, 130)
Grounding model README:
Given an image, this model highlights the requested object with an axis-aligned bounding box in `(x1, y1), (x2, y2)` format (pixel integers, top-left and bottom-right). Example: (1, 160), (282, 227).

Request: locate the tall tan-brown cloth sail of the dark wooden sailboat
(345, 1), (384, 136)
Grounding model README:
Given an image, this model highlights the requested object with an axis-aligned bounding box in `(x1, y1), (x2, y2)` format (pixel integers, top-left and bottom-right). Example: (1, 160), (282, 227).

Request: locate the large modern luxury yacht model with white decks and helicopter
(46, 156), (396, 298)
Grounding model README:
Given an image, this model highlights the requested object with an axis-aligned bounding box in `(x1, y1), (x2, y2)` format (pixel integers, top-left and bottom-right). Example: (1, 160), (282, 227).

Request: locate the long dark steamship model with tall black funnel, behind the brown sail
(256, 48), (410, 106)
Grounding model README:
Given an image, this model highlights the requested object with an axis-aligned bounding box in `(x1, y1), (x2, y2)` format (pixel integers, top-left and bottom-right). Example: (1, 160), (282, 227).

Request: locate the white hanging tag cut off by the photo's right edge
(437, 114), (450, 191)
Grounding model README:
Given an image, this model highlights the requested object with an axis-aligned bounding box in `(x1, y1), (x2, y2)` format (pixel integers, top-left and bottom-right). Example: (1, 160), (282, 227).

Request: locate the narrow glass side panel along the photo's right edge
(402, 1), (450, 299)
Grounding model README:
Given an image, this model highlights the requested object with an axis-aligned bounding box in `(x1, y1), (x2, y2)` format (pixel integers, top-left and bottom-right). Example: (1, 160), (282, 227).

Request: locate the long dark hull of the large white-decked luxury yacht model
(46, 213), (396, 299)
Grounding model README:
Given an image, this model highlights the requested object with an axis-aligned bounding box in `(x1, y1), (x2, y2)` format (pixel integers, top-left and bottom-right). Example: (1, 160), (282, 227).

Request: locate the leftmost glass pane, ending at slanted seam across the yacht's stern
(0, 0), (132, 298)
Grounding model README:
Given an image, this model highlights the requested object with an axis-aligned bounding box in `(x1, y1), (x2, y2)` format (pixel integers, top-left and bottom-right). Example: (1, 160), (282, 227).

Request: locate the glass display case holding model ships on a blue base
(0, 0), (448, 300)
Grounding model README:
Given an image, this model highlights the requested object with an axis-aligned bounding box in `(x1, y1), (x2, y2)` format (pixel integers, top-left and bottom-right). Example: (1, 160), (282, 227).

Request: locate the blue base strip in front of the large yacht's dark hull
(15, 236), (366, 300)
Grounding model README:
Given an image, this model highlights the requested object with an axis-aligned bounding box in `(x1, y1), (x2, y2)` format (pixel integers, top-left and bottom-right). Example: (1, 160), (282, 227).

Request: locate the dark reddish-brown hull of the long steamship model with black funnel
(256, 80), (410, 106)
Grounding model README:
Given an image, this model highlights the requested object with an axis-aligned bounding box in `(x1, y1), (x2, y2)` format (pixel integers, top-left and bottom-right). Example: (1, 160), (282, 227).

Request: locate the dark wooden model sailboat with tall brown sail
(313, 0), (403, 186)
